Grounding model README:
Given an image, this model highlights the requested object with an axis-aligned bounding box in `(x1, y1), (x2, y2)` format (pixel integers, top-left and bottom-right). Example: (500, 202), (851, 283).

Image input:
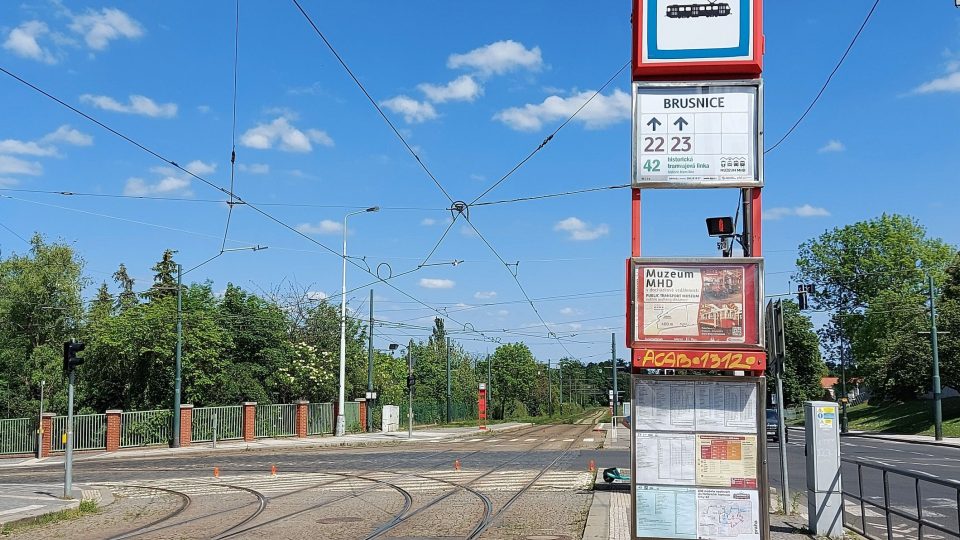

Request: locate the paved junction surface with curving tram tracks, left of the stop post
(0, 424), (597, 540)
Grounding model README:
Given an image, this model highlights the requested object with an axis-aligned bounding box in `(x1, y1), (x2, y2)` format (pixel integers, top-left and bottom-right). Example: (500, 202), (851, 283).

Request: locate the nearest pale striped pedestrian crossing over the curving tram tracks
(104, 468), (593, 499)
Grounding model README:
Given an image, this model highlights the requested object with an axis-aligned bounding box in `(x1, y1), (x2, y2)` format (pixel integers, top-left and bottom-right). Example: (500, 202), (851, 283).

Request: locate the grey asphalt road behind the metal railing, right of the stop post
(767, 429), (960, 538)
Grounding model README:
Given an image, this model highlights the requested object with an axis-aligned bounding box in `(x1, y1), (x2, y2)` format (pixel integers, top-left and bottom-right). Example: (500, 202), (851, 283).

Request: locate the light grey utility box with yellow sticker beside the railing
(803, 401), (843, 538)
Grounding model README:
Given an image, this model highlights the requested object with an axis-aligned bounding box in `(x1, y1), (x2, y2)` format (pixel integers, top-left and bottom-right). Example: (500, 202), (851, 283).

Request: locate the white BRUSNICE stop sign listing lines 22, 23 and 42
(633, 81), (763, 188)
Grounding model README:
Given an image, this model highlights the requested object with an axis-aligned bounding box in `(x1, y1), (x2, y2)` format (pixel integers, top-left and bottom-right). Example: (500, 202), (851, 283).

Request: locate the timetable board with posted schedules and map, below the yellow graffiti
(631, 375), (769, 540)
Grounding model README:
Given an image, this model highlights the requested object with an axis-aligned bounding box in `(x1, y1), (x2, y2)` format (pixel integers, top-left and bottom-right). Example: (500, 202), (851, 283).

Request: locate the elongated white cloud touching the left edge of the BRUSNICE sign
(493, 88), (630, 131)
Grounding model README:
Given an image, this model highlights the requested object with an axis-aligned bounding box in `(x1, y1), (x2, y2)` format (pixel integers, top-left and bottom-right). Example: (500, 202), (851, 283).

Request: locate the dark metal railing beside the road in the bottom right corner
(841, 458), (960, 540)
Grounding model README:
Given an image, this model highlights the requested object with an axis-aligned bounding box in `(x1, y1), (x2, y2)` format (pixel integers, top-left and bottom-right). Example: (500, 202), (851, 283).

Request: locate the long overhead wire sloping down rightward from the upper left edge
(0, 66), (506, 350)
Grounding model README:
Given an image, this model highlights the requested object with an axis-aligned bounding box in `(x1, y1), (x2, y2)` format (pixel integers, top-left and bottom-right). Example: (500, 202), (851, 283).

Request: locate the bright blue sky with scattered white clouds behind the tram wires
(0, 0), (960, 360)
